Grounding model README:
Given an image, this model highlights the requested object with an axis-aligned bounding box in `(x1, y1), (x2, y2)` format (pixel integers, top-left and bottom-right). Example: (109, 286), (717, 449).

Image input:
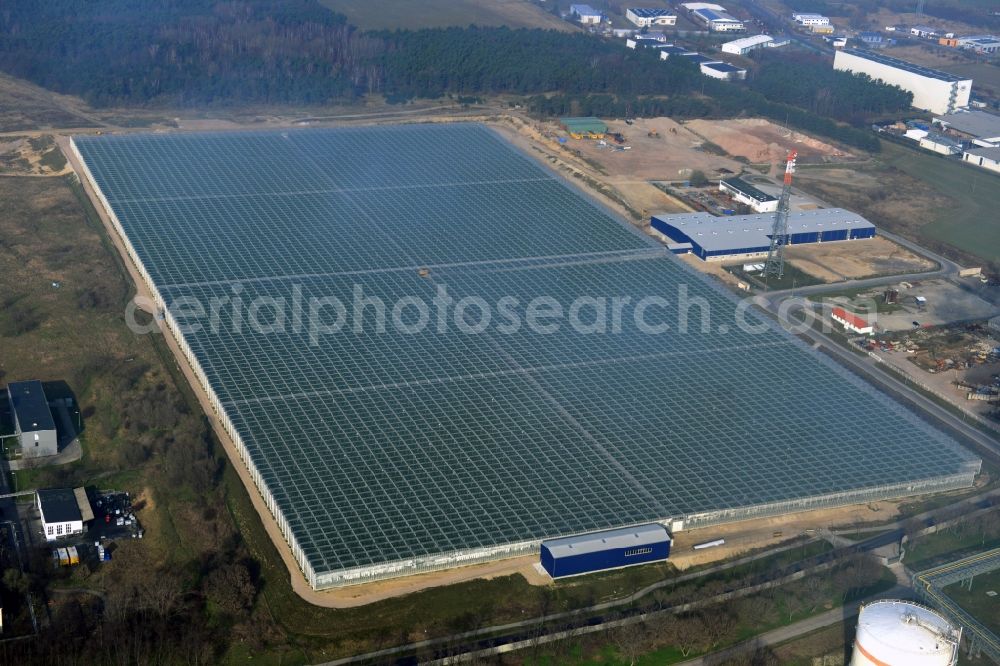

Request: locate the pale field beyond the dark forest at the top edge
(320, 0), (574, 30)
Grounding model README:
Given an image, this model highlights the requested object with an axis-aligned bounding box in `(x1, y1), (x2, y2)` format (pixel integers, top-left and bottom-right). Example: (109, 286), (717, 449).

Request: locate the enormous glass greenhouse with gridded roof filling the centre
(74, 123), (978, 587)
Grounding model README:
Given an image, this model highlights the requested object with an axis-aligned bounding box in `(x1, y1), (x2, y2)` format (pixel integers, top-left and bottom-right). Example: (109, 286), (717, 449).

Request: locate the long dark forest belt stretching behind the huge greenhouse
(0, 0), (908, 150)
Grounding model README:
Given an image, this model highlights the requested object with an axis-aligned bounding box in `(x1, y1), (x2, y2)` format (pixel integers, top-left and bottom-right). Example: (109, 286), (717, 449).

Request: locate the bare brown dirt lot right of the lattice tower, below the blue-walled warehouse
(785, 238), (937, 282)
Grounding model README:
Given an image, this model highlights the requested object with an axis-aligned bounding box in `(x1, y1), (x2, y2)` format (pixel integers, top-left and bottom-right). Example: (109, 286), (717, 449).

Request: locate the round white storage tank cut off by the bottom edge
(851, 601), (962, 666)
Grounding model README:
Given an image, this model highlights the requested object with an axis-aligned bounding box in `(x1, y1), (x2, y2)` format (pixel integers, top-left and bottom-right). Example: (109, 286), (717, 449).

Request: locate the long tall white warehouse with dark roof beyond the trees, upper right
(833, 48), (972, 113)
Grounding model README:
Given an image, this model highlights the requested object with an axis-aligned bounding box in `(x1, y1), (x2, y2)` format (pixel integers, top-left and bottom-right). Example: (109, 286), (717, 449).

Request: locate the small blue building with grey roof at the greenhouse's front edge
(542, 523), (670, 578)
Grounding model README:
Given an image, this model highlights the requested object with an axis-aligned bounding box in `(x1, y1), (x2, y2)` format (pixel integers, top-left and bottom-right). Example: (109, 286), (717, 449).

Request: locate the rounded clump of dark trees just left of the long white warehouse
(749, 53), (913, 122)
